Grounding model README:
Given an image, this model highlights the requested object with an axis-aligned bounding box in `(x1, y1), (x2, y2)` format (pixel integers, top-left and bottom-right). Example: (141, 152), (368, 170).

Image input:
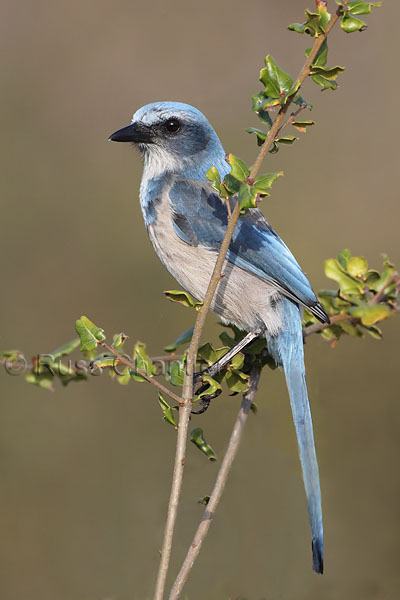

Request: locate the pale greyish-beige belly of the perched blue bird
(147, 199), (282, 334)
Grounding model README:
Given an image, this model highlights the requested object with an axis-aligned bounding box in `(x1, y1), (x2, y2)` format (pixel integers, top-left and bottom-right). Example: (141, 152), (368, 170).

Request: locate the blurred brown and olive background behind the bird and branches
(0, 0), (400, 600)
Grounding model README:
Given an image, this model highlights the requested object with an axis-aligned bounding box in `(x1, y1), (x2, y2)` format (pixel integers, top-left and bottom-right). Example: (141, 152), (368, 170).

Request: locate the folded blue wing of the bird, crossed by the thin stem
(169, 180), (329, 322)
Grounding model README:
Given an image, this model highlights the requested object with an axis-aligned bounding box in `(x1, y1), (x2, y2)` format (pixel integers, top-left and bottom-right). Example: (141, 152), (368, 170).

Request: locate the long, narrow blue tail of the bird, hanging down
(267, 298), (323, 573)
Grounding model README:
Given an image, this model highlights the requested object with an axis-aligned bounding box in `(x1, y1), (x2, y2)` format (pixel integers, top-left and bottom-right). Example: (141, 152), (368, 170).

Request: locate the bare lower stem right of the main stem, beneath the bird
(168, 369), (261, 600)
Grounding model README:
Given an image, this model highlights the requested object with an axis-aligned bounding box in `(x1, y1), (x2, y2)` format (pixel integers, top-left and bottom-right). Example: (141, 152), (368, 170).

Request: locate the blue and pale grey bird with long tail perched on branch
(110, 102), (329, 573)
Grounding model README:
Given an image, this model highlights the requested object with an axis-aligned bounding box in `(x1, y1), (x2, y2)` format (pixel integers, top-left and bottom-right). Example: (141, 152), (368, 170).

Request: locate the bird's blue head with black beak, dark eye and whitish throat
(110, 102), (229, 179)
